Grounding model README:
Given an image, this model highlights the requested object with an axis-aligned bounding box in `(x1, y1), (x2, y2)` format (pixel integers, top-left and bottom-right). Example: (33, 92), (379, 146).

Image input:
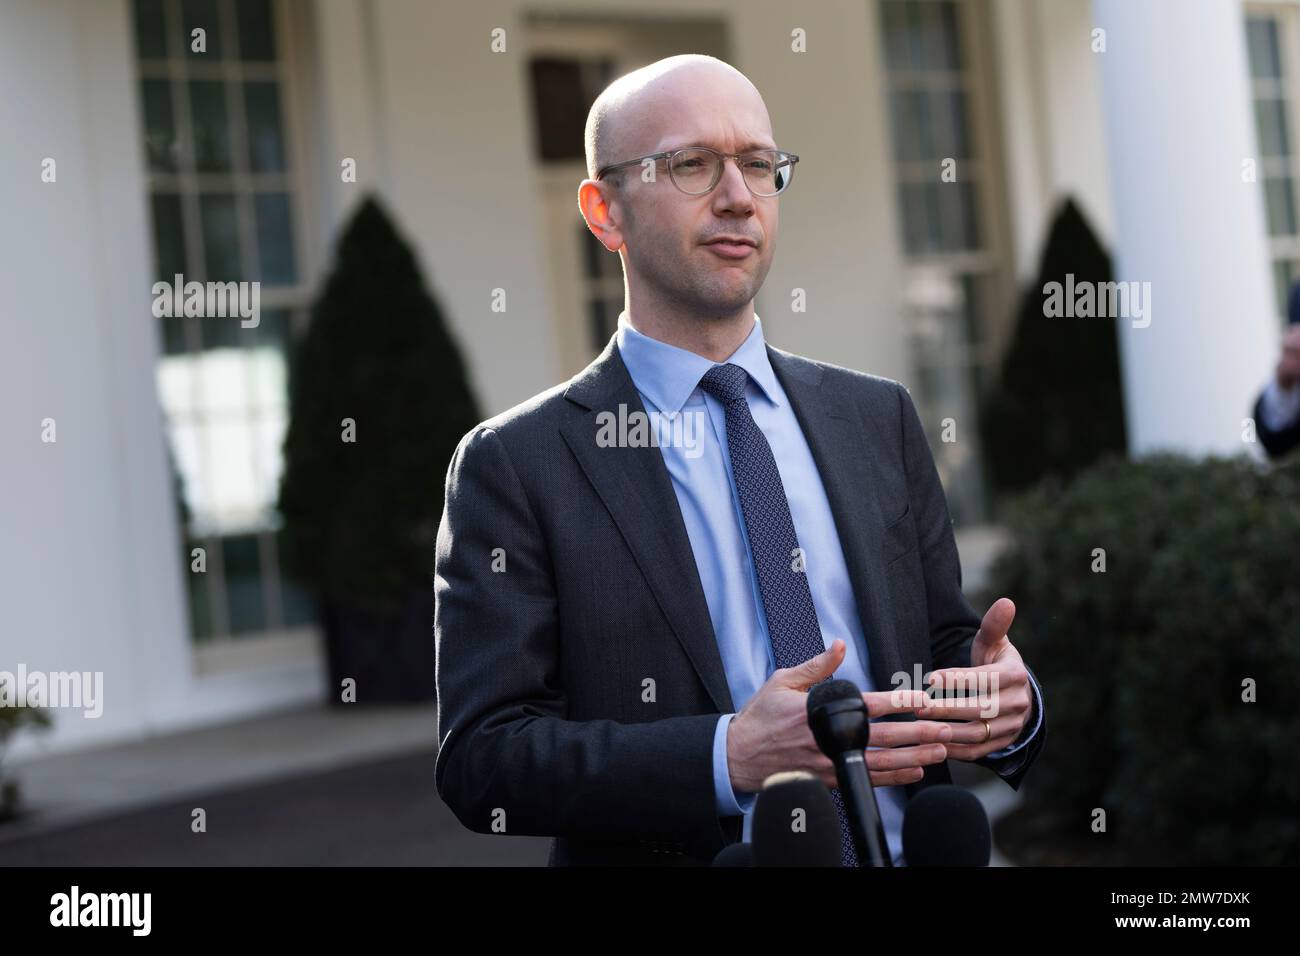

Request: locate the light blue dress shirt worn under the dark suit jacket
(618, 312), (1043, 865)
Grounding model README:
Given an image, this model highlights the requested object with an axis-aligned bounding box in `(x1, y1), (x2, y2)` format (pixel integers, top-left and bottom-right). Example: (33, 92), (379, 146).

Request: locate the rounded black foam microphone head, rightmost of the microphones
(902, 784), (993, 866)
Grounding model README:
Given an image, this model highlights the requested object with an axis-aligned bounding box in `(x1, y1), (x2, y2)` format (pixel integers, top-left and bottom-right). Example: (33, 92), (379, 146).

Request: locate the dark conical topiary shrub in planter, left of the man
(280, 198), (480, 702)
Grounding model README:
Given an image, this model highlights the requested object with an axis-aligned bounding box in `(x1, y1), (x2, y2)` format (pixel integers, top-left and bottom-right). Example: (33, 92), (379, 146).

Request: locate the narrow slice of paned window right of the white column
(1245, 9), (1300, 324)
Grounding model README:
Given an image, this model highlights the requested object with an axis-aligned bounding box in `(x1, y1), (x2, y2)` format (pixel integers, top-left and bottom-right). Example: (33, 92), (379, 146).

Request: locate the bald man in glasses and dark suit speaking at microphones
(434, 55), (1045, 865)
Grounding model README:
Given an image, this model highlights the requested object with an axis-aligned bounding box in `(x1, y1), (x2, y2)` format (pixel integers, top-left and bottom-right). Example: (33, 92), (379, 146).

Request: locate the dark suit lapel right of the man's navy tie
(767, 345), (904, 691)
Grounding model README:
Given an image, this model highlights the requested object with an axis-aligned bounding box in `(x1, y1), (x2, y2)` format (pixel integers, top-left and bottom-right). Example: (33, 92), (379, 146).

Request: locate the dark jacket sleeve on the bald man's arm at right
(898, 385), (1048, 790)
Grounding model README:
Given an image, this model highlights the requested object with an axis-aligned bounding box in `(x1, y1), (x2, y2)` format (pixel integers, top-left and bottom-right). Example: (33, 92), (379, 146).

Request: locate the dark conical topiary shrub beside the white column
(980, 199), (1127, 496)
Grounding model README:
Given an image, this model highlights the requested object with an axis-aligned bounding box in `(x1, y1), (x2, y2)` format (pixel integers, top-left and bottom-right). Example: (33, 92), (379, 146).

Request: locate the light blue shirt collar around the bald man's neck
(618, 310), (781, 412)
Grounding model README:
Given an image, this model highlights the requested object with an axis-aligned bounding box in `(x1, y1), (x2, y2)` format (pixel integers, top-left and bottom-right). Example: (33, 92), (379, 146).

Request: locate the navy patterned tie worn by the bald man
(699, 364), (858, 866)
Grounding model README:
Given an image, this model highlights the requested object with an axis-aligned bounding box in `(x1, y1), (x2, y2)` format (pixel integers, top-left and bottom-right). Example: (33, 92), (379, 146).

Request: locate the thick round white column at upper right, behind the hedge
(1078, 0), (1278, 454)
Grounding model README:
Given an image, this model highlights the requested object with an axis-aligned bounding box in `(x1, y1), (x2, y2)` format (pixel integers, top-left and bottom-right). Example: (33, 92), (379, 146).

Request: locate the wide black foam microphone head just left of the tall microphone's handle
(753, 770), (840, 866)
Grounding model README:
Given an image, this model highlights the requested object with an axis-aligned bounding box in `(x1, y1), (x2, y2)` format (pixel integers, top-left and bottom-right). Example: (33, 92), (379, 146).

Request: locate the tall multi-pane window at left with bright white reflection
(133, 0), (315, 641)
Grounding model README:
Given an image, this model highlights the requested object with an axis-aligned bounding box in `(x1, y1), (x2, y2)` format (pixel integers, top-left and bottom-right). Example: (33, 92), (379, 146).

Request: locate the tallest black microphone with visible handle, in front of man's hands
(809, 680), (893, 866)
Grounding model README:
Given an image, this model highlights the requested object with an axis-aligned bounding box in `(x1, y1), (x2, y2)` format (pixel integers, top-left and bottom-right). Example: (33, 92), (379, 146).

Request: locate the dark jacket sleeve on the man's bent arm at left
(434, 425), (724, 851)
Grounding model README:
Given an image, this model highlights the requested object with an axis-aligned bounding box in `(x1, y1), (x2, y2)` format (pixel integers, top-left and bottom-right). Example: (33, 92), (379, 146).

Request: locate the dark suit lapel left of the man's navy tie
(560, 338), (736, 713)
